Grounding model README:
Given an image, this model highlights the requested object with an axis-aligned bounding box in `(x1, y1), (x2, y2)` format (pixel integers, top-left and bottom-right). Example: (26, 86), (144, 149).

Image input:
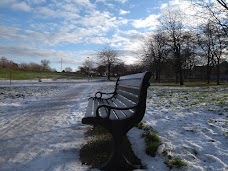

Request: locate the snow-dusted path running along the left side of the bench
(0, 84), (91, 171)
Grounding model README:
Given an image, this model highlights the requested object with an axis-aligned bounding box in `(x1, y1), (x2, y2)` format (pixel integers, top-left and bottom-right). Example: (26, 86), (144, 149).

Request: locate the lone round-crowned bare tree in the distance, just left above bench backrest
(97, 46), (119, 80)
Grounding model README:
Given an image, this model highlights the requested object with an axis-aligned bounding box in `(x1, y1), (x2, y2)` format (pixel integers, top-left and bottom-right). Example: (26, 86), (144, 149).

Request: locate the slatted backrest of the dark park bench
(115, 72), (151, 120)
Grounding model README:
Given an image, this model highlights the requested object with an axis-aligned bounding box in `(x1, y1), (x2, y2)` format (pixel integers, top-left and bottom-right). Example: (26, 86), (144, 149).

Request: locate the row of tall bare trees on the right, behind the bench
(141, 0), (228, 85)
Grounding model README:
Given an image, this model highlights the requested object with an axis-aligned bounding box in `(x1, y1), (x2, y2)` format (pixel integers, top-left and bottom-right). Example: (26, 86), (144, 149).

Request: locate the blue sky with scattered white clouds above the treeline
(0, 0), (201, 71)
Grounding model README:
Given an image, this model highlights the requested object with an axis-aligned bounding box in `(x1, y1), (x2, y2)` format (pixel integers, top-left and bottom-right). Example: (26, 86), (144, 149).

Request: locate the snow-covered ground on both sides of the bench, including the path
(0, 80), (228, 171)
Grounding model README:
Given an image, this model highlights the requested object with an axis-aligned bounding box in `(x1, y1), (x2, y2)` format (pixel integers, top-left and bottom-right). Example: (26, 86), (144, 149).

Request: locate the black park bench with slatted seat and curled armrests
(82, 72), (151, 170)
